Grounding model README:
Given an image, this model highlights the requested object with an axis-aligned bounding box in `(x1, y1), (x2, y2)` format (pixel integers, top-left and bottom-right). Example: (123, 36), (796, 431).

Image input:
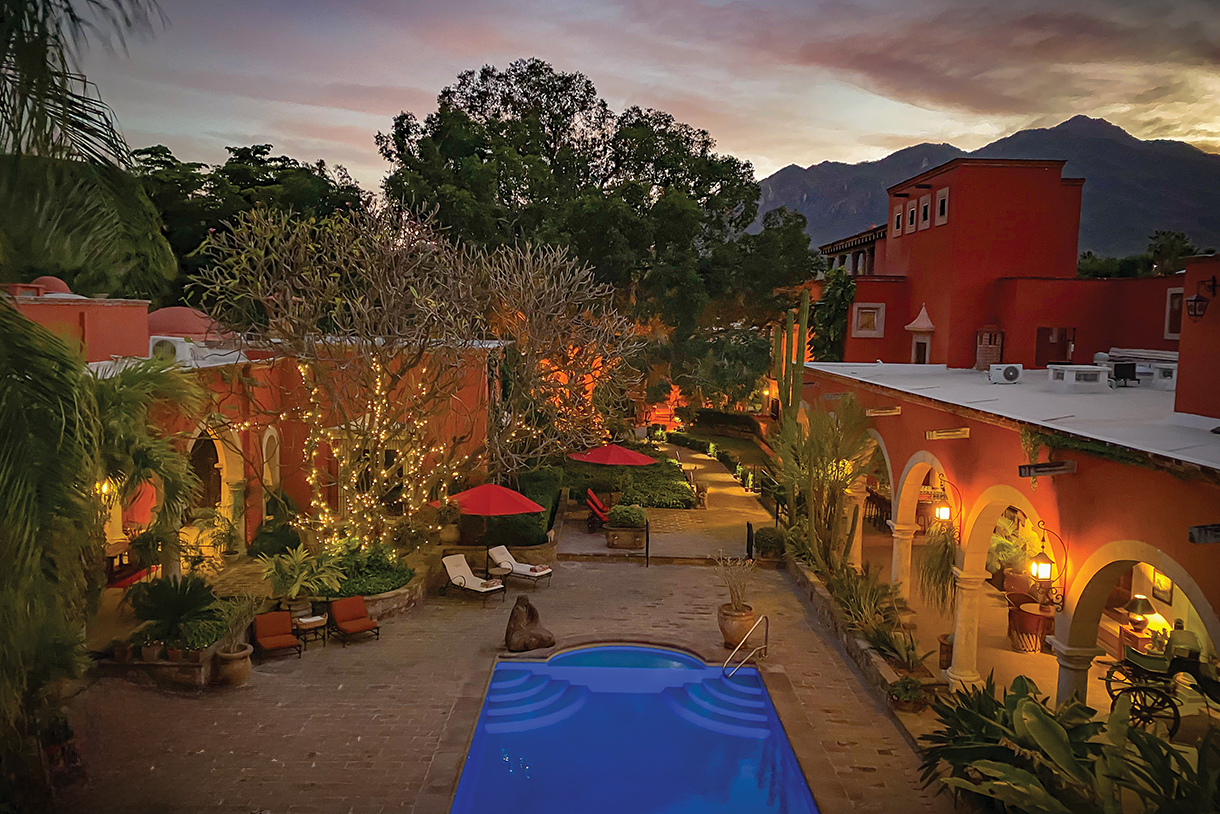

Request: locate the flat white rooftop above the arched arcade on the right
(806, 362), (1220, 470)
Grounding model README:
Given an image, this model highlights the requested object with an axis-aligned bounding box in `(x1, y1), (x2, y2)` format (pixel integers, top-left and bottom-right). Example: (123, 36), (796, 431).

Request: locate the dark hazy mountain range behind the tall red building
(759, 116), (1220, 256)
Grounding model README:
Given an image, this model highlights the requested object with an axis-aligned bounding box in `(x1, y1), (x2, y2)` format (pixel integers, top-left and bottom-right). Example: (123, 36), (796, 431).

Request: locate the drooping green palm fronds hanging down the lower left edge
(0, 303), (101, 807)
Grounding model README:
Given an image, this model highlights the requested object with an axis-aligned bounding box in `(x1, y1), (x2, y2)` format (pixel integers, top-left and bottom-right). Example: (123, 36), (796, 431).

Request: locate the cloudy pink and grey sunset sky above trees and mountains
(84, 0), (1220, 188)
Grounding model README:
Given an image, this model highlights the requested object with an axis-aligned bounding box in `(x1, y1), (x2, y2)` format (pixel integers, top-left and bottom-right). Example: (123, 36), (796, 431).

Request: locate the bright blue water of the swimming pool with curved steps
(450, 646), (817, 814)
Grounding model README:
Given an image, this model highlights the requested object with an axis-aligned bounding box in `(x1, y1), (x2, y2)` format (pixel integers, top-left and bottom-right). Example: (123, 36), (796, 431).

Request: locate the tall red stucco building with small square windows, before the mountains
(821, 159), (1182, 367)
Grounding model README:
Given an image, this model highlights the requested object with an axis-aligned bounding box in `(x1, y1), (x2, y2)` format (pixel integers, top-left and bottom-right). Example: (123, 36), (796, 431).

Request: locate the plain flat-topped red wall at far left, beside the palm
(10, 297), (149, 361)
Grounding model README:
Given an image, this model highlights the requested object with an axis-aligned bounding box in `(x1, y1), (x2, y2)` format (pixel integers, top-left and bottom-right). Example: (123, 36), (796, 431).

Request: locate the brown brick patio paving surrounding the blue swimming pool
(59, 563), (950, 814)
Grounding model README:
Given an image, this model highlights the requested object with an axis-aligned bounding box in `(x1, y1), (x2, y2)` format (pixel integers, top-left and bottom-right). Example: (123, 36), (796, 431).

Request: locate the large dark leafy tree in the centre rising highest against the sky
(377, 59), (817, 407)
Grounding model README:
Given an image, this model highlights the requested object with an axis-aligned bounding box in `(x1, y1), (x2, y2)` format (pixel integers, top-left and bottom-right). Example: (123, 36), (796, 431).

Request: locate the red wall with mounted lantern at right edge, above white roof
(1175, 255), (1220, 419)
